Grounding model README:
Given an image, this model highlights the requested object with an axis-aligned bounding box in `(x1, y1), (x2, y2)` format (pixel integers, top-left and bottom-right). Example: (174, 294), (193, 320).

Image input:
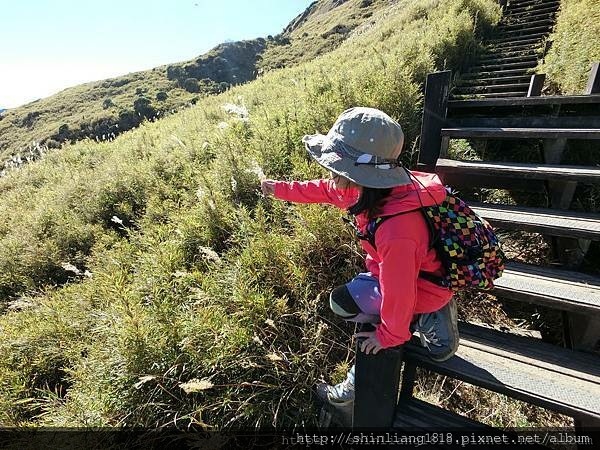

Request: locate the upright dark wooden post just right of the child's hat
(419, 70), (452, 170)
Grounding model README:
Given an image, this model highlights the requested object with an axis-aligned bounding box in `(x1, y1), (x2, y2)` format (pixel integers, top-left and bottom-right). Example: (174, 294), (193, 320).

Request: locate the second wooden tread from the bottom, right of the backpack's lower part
(492, 263), (600, 316)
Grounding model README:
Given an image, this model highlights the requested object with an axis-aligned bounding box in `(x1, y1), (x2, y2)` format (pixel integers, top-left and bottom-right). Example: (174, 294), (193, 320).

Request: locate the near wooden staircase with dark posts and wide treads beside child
(346, 58), (600, 444)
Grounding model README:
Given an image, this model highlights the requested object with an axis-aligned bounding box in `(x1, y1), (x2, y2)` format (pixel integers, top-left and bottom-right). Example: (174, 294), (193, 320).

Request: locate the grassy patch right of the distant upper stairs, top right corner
(537, 0), (600, 95)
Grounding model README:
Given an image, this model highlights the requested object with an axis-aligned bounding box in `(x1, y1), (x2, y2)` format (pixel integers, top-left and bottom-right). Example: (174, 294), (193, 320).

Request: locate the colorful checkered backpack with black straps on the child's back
(346, 190), (505, 291)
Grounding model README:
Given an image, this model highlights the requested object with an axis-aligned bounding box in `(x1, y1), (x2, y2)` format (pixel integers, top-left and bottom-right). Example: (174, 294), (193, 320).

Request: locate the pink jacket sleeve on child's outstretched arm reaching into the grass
(274, 180), (360, 209)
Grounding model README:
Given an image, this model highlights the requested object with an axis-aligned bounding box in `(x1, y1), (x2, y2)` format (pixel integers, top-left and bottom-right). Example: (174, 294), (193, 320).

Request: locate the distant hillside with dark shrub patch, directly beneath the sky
(0, 0), (395, 175)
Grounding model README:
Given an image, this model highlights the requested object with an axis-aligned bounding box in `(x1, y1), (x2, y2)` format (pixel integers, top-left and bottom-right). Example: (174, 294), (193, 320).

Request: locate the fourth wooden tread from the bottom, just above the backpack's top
(435, 159), (600, 185)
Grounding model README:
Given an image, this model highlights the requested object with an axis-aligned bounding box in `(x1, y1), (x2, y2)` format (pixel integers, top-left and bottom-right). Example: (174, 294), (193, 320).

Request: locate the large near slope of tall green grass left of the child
(0, 0), (502, 428)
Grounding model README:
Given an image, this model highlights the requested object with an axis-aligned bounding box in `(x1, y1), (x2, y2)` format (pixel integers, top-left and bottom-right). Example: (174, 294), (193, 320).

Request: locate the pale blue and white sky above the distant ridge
(0, 0), (313, 109)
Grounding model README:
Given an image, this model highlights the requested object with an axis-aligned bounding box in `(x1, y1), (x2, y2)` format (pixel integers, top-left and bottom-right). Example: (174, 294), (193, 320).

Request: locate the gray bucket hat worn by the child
(302, 107), (411, 188)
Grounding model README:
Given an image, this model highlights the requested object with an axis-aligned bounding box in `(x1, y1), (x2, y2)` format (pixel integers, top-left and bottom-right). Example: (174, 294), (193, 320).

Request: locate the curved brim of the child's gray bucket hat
(302, 134), (412, 188)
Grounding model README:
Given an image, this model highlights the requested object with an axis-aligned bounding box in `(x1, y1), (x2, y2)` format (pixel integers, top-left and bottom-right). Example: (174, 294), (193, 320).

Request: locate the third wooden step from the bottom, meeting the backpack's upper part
(470, 203), (600, 241)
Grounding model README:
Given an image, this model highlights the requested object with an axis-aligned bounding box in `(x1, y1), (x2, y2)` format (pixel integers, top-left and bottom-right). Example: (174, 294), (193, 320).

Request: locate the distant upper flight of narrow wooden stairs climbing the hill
(450, 0), (560, 100)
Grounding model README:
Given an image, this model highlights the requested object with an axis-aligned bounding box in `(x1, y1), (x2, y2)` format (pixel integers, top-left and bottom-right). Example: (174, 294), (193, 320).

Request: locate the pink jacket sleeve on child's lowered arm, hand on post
(376, 238), (421, 348)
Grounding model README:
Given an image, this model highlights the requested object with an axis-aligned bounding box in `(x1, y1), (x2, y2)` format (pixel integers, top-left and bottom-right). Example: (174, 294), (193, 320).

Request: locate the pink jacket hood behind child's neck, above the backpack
(380, 171), (447, 216)
